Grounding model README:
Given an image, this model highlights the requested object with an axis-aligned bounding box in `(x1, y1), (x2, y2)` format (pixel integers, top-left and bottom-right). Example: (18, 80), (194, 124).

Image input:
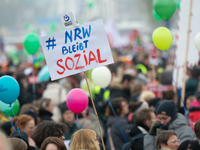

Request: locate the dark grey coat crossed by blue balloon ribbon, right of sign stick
(106, 116), (131, 150)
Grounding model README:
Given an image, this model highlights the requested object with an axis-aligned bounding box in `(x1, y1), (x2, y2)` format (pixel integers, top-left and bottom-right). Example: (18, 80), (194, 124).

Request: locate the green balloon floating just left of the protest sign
(24, 33), (40, 55)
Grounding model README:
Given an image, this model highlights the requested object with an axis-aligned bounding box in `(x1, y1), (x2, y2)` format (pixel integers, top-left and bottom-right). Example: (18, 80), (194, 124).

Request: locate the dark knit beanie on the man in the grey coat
(156, 100), (176, 117)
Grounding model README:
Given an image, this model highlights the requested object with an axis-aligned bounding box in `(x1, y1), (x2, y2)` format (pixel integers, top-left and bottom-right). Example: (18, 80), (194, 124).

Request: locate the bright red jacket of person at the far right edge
(188, 100), (200, 131)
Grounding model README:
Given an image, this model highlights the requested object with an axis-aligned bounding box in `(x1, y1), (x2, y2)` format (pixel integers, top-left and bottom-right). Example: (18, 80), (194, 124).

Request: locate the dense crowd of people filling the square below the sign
(0, 41), (200, 150)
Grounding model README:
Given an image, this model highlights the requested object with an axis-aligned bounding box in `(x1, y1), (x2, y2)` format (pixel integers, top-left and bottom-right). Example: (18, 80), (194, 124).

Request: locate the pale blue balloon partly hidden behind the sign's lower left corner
(38, 65), (50, 82)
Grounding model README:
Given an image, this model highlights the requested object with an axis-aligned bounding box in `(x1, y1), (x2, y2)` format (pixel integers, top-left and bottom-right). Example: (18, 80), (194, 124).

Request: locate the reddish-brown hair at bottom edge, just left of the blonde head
(40, 137), (67, 150)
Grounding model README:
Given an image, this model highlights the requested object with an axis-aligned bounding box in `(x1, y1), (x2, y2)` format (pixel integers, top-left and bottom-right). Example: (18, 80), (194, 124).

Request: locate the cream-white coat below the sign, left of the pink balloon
(42, 82), (67, 122)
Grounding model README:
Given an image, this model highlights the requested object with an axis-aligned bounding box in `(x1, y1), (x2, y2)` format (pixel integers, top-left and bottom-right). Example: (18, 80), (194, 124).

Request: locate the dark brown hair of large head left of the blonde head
(32, 120), (68, 148)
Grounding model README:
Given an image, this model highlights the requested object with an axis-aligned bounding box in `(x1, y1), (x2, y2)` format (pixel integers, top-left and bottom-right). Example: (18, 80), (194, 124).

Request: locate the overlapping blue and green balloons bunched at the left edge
(0, 75), (20, 117)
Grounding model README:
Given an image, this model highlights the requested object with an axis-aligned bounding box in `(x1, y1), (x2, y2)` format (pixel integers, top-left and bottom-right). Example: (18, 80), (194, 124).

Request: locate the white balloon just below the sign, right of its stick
(92, 66), (111, 88)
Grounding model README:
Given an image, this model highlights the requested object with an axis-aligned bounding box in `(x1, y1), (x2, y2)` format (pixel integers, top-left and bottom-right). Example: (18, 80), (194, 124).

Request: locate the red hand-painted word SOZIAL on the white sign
(56, 49), (107, 75)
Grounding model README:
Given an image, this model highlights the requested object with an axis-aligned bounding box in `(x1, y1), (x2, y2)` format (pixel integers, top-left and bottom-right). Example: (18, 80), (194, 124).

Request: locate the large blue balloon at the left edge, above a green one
(0, 75), (20, 104)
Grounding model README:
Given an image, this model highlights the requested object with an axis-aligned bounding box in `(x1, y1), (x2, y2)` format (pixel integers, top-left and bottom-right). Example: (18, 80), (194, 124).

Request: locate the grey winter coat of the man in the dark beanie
(144, 113), (195, 150)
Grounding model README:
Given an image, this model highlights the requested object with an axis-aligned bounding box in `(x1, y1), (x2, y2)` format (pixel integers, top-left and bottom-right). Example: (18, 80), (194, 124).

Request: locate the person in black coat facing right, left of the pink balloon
(39, 98), (54, 122)
